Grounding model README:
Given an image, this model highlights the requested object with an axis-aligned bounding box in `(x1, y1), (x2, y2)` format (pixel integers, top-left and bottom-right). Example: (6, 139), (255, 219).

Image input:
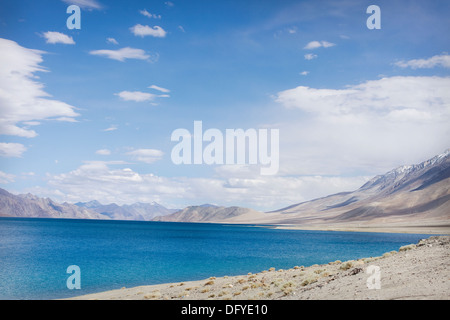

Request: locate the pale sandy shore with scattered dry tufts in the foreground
(67, 236), (450, 300)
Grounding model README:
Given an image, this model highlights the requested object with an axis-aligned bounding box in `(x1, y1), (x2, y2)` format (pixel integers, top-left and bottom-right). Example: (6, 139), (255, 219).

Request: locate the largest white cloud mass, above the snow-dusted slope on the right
(275, 77), (450, 175)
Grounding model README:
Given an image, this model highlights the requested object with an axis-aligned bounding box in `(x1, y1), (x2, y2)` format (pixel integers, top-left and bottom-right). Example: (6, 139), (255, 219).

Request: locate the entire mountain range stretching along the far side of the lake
(0, 149), (450, 230)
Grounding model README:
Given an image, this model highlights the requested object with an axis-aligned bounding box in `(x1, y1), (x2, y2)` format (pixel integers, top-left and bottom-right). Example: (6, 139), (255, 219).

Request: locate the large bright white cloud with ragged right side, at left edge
(0, 38), (79, 138)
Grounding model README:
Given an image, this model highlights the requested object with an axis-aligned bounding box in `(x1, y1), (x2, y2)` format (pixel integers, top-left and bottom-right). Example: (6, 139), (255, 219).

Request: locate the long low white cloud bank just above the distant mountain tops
(36, 160), (368, 210)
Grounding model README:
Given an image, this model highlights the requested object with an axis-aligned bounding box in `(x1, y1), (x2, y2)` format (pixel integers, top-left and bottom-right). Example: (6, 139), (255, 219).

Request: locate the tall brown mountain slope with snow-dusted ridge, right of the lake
(227, 150), (450, 227)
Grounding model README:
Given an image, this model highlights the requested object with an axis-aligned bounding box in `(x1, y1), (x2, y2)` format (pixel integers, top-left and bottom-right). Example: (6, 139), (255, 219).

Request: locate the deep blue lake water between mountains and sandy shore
(0, 218), (429, 300)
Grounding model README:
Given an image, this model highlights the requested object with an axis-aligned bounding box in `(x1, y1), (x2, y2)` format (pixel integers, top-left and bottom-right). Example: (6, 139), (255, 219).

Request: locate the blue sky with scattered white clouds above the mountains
(0, 0), (450, 211)
